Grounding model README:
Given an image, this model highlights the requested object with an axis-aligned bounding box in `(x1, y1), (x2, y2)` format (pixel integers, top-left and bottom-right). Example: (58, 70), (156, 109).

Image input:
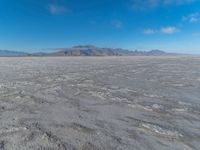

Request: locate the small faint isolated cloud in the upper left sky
(48, 4), (70, 15)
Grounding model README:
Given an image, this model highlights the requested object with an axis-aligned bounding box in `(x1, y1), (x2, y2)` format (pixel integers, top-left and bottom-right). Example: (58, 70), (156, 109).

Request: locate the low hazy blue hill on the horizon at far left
(0, 50), (28, 57)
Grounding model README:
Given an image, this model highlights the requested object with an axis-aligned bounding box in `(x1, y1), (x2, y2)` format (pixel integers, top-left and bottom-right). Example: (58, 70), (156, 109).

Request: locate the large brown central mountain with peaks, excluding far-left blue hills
(48, 45), (167, 56)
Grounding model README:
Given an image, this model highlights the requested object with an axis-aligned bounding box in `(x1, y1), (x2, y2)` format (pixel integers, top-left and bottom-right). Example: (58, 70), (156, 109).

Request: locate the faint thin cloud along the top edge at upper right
(131, 0), (196, 10)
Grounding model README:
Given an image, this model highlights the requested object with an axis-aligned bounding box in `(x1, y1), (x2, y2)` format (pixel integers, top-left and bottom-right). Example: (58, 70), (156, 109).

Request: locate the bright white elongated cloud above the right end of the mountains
(143, 26), (180, 35)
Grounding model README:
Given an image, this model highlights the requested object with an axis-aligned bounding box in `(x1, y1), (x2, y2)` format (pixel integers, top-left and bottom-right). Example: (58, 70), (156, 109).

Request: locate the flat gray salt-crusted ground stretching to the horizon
(0, 57), (200, 150)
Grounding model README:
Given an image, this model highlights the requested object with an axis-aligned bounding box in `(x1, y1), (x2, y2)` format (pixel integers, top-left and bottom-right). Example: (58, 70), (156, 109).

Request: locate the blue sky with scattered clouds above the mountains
(0, 0), (200, 54)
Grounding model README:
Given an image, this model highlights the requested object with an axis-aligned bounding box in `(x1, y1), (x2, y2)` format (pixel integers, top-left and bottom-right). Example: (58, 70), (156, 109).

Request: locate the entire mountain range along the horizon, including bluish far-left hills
(0, 45), (172, 57)
